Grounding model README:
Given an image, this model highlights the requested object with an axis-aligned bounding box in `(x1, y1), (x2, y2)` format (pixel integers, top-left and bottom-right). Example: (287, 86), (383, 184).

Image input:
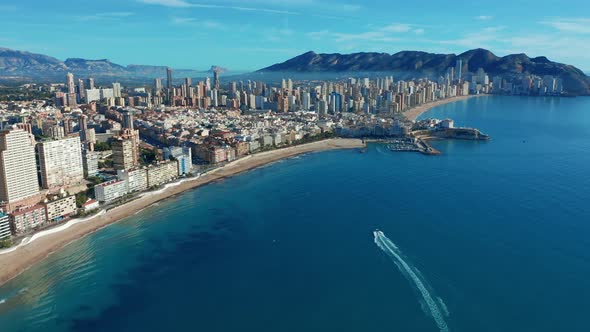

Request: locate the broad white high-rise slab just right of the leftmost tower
(37, 136), (84, 189)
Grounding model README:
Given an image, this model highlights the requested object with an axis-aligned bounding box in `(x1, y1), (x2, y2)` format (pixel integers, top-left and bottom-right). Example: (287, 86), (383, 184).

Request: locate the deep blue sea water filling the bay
(0, 97), (590, 332)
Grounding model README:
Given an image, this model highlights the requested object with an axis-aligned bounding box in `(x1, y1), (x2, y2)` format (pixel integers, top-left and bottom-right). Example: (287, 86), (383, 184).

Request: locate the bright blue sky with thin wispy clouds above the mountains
(0, 0), (590, 72)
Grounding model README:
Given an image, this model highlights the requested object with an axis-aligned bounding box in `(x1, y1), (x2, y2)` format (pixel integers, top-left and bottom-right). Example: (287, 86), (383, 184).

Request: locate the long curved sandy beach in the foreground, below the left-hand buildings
(0, 139), (364, 285)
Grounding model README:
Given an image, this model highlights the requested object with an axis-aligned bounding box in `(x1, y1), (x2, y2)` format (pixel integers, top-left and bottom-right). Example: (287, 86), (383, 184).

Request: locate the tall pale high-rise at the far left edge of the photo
(0, 129), (39, 203)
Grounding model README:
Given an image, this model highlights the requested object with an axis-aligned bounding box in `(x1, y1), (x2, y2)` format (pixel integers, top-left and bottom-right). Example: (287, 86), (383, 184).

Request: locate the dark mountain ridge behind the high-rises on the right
(257, 48), (590, 95)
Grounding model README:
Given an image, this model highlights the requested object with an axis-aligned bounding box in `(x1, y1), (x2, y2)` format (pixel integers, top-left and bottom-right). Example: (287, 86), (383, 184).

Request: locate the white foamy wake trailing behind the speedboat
(373, 231), (449, 332)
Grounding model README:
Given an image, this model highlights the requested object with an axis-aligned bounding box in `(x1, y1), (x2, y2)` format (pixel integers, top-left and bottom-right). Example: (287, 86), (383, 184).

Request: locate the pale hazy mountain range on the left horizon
(0, 48), (225, 82)
